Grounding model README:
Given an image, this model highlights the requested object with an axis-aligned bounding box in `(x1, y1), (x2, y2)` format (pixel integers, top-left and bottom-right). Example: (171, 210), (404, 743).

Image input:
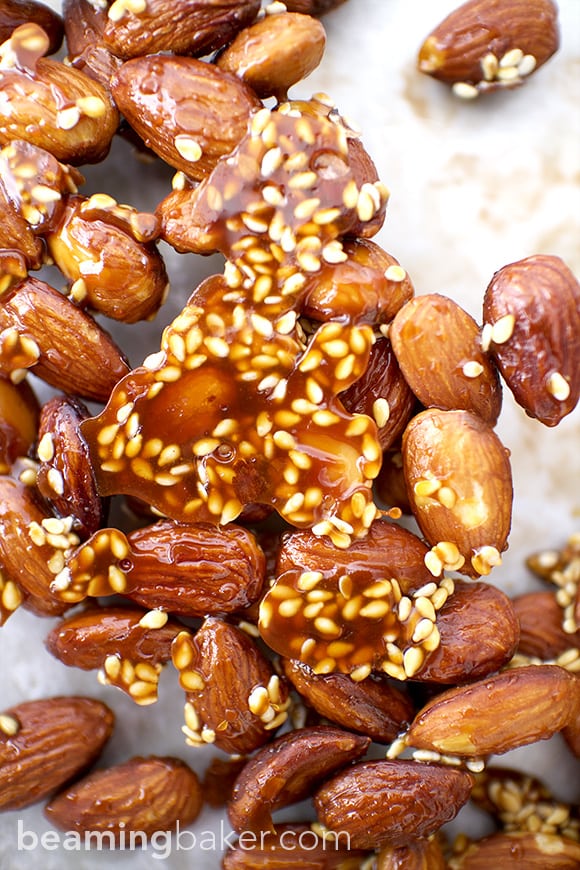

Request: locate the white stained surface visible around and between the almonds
(0, 0), (580, 870)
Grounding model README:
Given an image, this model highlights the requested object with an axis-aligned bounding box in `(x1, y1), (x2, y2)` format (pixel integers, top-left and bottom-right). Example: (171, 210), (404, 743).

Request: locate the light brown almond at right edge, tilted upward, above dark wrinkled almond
(407, 665), (580, 757)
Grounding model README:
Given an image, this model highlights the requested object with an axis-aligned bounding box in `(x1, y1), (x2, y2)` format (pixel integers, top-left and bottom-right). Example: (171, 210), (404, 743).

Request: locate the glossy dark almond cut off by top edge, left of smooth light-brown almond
(103, 0), (260, 58)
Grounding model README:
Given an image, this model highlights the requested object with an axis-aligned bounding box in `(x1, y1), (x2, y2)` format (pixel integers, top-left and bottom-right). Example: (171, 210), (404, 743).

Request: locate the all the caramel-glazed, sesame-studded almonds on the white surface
(0, 0), (580, 870)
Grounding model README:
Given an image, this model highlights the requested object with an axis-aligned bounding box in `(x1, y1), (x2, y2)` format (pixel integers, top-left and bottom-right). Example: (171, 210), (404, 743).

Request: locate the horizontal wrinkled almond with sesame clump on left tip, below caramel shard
(53, 520), (265, 617)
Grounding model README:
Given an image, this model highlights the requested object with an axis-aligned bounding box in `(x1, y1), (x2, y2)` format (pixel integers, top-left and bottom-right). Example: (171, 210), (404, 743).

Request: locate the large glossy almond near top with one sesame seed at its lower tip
(112, 55), (262, 181)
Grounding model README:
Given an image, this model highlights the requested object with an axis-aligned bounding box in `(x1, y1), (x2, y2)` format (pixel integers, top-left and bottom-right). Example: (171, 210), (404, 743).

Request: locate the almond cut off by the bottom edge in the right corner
(449, 833), (580, 870)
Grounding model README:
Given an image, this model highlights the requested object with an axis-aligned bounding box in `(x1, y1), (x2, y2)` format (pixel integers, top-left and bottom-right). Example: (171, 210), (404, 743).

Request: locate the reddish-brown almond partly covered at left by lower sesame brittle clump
(414, 580), (519, 683)
